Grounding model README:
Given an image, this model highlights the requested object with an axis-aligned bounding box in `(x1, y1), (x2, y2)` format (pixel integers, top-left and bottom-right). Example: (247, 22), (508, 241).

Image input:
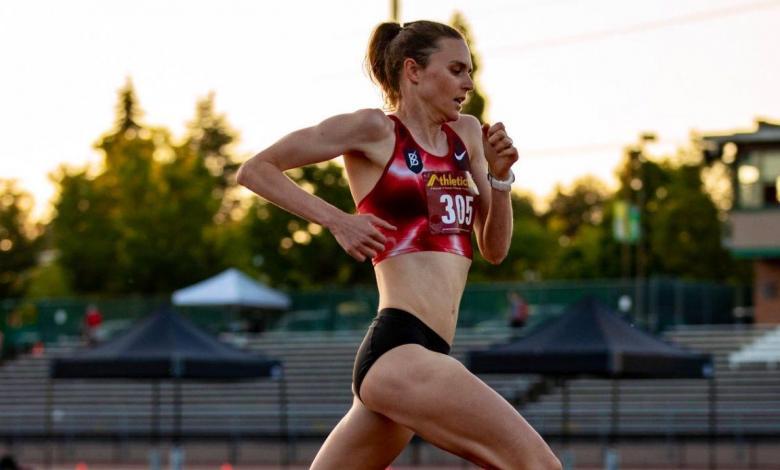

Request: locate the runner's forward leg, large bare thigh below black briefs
(360, 344), (561, 470)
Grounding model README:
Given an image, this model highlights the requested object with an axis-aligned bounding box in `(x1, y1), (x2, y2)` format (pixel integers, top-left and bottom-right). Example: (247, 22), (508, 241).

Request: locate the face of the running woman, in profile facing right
(417, 38), (474, 121)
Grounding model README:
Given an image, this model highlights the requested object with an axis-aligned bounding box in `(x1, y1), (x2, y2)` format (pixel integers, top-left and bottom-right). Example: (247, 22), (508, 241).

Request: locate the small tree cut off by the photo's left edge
(0, 179), (40, 298)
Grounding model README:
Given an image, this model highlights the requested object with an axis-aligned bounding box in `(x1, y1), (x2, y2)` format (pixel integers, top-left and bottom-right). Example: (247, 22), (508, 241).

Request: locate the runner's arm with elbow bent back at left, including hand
(236, 109), (395, 261)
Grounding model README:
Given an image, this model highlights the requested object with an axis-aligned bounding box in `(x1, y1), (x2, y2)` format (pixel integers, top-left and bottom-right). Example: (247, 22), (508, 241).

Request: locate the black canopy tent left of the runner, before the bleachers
(47, 308), (287, 468)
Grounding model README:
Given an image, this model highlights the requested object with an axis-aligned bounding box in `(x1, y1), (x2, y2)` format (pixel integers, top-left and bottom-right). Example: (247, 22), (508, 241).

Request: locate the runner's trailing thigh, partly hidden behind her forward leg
(311, 398), (414, 470)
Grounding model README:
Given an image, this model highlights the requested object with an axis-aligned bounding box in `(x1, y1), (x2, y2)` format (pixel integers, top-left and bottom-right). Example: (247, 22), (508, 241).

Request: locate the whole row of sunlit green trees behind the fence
(0, 71), (749, 297)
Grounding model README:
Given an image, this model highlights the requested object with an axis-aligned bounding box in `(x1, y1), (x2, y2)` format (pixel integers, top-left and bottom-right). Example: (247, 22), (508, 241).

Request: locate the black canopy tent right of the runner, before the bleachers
(467, 297), (716, 470)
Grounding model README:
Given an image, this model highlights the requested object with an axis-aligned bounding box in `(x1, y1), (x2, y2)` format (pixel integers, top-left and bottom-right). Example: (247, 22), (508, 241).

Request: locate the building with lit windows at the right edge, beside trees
(703, 120), (780, 323)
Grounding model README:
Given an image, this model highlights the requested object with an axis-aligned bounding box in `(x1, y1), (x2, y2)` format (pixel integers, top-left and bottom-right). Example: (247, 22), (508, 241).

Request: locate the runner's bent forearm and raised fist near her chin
(465, 117), (518, 264)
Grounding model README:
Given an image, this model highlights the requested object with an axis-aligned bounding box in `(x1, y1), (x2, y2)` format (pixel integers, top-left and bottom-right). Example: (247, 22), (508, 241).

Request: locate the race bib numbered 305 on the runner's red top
(422, 171), (476, 235)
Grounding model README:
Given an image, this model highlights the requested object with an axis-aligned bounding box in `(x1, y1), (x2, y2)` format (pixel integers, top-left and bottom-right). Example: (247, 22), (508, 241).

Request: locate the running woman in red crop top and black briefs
(238, 21), (561, 470)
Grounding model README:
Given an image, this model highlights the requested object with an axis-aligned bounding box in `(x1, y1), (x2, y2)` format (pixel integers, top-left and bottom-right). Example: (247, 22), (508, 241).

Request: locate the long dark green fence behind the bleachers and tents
(0, 278), (752, 349)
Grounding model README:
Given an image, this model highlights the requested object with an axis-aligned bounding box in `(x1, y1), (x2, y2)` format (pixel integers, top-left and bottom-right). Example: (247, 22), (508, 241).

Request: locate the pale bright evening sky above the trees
(0, 0), (780, 219)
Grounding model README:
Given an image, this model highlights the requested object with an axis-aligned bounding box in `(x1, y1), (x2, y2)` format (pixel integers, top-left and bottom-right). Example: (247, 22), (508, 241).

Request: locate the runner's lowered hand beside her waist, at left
(328, 214), (396, 261)
